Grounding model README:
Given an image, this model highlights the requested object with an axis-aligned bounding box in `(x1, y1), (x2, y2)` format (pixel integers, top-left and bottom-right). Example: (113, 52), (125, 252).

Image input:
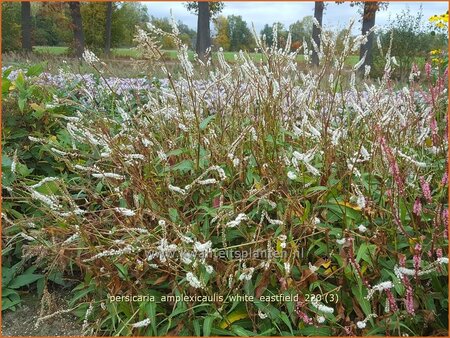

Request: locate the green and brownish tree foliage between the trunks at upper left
(2, 2), (149, 52)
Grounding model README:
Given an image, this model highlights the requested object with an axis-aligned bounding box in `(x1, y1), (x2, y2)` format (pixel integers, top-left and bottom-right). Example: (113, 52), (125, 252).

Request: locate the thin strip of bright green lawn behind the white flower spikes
(33, 46), (359, 66)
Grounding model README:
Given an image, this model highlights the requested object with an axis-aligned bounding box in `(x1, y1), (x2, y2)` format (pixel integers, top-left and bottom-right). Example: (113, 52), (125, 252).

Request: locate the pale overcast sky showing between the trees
(146, 1), (448, 33)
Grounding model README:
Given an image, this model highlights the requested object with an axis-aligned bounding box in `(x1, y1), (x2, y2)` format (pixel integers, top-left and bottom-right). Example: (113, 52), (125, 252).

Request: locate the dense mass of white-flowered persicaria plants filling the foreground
(2, 19), (448, 336)
